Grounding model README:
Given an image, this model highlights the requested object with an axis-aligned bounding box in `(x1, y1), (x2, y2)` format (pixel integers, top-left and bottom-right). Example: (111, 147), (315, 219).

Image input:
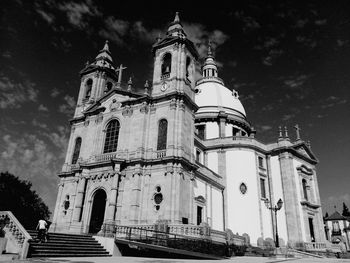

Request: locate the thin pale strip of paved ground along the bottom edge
(0, 256), (350, 263)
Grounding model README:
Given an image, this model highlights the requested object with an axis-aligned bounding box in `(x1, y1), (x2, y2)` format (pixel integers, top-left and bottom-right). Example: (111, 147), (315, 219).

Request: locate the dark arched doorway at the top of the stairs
(89, 189), (107, 234)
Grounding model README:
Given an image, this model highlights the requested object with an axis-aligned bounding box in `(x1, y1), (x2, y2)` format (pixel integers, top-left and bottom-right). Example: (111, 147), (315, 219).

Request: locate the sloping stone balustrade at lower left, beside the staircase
(0, 211), (32, 259)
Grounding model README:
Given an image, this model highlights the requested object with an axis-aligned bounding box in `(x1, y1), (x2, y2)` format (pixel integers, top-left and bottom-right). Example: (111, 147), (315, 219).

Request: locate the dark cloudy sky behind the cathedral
(0, 0), (350, 218)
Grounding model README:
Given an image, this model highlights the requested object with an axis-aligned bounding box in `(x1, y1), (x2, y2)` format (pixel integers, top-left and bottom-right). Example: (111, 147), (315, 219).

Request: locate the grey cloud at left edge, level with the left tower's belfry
(0, 76), (39, 109)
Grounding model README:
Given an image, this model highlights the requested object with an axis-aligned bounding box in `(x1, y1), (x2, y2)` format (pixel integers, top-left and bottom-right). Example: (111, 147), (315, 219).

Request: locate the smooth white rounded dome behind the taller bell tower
(195, 78), (246, 119)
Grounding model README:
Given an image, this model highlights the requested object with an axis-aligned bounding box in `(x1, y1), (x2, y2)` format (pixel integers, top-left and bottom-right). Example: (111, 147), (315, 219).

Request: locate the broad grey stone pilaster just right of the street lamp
(279, 152), (302, 245)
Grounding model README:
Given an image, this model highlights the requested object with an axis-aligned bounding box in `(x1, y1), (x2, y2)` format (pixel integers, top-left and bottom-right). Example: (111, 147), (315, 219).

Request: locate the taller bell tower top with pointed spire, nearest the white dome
(152, 12), (198, 100)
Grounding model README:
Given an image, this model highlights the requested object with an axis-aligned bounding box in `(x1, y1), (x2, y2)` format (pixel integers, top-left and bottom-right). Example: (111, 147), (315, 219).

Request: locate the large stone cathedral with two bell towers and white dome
(51, 14), (325, 250)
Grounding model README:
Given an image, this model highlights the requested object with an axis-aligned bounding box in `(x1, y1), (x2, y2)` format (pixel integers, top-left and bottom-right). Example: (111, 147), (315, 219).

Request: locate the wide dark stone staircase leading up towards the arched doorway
(27, 230), (111, 258)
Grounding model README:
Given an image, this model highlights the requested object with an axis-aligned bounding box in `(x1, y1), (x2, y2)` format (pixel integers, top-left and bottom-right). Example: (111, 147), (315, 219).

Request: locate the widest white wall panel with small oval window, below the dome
(226, 150), (262, 245)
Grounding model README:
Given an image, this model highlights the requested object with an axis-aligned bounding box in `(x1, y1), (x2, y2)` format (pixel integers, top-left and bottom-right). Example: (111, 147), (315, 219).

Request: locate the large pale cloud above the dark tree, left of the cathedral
(0, 133), (67, 212)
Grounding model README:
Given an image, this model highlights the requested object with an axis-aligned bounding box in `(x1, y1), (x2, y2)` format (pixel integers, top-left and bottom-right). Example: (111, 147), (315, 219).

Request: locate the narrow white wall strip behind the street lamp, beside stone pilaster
(270, 156), (288, 243)
